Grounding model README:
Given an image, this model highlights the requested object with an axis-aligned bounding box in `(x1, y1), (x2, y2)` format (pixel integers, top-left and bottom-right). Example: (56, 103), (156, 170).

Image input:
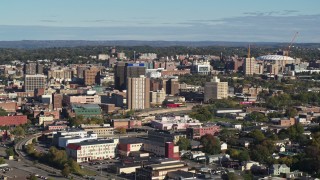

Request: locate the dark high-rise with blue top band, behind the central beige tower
(114, 63), (146, 91)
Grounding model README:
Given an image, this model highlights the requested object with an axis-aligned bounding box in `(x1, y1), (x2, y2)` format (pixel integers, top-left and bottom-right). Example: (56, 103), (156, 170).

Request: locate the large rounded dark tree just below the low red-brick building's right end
(200, 134), (221, 154)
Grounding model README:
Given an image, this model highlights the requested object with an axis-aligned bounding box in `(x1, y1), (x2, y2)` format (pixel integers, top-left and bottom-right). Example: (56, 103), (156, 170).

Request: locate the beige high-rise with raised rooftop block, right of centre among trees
(204, 76), (228, 102)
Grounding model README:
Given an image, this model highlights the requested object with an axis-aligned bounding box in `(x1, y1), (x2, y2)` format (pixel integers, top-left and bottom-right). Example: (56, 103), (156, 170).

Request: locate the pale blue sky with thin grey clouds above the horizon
(0, 0), (320, 43)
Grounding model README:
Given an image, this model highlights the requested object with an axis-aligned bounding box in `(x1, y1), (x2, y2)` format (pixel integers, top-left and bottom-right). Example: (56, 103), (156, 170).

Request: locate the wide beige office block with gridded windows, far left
(24, 74), (47, 92)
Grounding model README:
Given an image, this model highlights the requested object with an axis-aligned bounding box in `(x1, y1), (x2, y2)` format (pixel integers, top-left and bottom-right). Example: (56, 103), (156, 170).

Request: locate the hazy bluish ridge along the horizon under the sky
(0, 40), (320, 49)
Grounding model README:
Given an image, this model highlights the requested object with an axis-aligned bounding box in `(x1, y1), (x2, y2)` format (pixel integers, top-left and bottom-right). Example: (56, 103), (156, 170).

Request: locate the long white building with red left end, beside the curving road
(66, 139), (119, 162)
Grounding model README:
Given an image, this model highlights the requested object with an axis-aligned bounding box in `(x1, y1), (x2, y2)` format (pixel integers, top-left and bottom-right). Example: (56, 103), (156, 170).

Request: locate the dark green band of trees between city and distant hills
(0, 46), (320, 63)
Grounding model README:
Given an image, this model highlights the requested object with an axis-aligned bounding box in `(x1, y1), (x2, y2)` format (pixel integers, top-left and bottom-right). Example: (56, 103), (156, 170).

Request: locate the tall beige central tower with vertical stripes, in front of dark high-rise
(127, 75), (150, 110)
